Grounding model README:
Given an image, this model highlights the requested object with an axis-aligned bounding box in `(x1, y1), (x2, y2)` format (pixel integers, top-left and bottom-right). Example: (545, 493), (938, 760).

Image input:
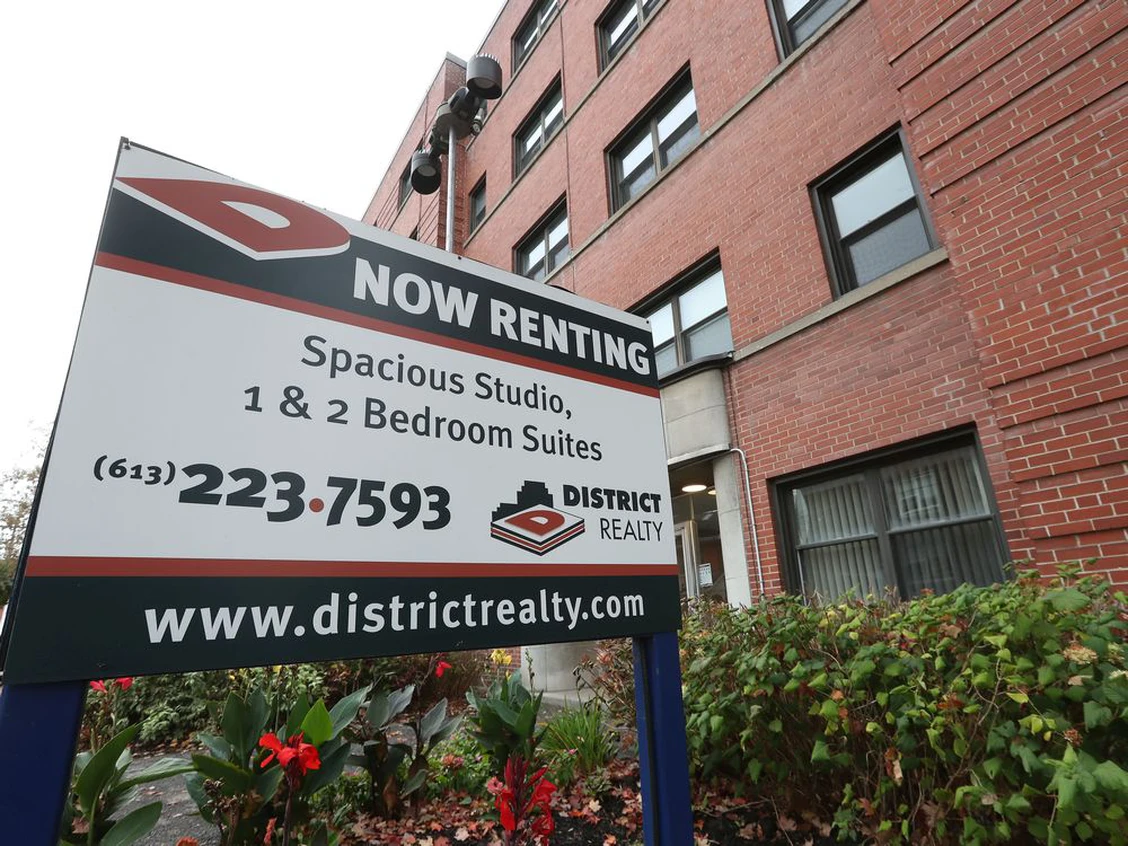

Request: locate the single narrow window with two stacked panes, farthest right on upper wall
(814, 133), (934, 294)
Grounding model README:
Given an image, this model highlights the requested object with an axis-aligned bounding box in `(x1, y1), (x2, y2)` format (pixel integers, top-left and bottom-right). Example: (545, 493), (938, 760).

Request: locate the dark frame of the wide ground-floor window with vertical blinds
(768, 426), (1011, 597)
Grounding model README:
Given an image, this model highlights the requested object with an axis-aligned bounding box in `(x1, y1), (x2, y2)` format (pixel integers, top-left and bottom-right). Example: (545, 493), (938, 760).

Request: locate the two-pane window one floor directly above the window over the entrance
(609, 73), (700, 209)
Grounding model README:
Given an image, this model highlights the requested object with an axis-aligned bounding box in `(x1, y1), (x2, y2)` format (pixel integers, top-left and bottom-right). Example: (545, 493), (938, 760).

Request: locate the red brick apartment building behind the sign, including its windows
(364, 0), (1128, 602)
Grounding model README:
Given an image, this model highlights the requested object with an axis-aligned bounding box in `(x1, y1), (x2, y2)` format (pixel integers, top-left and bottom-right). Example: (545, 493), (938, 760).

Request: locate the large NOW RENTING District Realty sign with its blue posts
(0, 142), (688, 843)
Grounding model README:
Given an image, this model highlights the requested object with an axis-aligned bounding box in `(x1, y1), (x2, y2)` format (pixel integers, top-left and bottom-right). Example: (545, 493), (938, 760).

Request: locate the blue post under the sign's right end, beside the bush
(634, 632), (694, 846)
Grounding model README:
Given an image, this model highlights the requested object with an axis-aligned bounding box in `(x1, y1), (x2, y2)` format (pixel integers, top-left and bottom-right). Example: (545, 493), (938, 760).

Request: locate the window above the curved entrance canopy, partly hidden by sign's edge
(646, 262), (732, 377)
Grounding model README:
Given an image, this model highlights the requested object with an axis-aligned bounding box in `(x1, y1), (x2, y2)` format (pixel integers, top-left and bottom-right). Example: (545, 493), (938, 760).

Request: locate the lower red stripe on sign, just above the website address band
(27, 555), (678, 579)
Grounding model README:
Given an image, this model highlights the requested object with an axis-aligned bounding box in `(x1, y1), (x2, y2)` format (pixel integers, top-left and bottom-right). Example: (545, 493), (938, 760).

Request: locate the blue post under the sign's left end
(0, 681), (86, 846)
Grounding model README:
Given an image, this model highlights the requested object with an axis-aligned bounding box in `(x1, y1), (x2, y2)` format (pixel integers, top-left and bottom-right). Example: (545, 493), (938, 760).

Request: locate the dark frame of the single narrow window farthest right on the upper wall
(810, 126), (940, 298)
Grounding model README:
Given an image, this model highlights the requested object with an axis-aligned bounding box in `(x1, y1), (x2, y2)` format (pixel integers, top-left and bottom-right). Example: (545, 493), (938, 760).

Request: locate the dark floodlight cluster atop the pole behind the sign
(411, 55), (501, 194)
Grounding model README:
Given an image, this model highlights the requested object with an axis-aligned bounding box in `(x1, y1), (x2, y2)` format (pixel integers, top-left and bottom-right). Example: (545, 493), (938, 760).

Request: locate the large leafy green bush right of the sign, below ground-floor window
(682, 573), (1128, 844)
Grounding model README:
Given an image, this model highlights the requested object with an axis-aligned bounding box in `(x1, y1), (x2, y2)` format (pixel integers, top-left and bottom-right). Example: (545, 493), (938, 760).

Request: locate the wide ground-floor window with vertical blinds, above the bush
(777, 437), (1004, 599)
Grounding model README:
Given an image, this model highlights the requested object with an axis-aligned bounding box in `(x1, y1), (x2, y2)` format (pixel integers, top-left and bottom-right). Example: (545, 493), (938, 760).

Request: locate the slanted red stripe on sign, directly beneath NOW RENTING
(94, 253), (659, 397)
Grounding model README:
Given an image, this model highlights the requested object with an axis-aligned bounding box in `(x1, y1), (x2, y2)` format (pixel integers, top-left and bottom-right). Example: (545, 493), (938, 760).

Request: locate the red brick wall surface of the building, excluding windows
(365, 0), (1128, 589)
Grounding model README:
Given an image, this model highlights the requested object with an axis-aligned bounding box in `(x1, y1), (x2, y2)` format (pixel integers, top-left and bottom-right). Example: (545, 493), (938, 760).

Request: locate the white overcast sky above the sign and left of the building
(0, 0), (502, 473)
